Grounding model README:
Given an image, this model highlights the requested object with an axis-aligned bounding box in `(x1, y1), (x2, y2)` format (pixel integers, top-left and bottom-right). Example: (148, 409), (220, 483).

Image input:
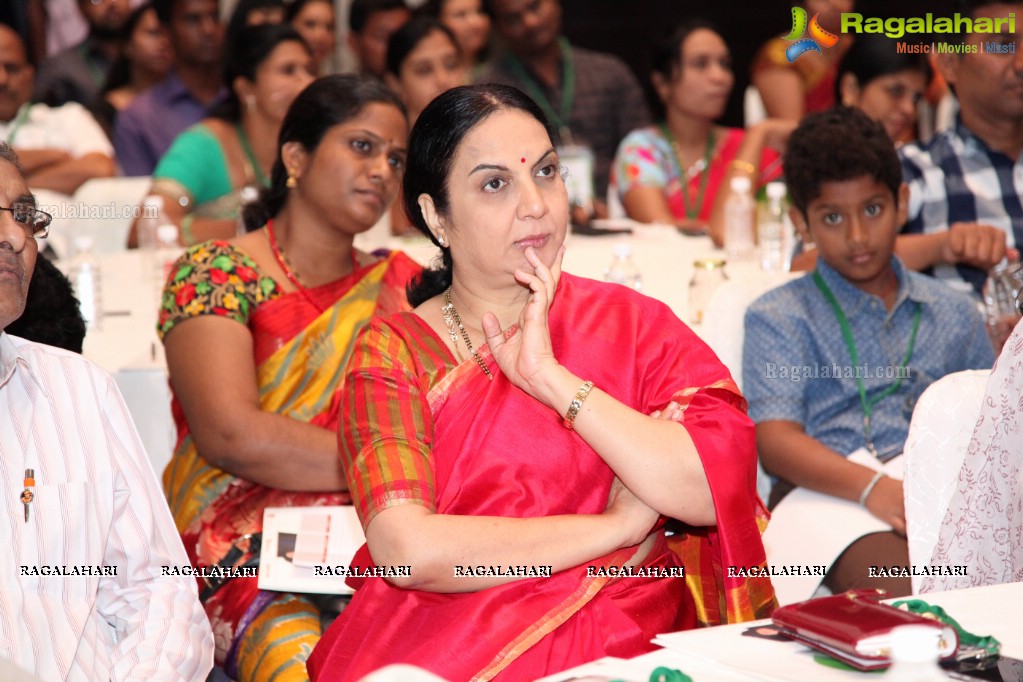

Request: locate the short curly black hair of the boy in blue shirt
(784, 106), (902, 216)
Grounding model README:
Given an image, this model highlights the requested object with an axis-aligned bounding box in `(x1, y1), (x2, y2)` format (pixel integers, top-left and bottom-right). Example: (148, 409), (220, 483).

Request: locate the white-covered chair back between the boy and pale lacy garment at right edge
(903, 369), (991, 594)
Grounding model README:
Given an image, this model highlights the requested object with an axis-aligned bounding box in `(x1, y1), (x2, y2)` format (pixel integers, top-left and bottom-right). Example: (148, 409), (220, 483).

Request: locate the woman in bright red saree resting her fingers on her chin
(308, 86), (773, 680)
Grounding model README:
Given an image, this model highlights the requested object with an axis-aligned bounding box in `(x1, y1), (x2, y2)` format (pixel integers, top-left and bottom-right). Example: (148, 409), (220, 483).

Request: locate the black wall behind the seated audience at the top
(562, 0), (957, 126)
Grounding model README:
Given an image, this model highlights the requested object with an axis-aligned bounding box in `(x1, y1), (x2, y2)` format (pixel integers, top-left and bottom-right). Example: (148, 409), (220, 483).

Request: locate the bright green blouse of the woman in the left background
(152, 123), (233, 207)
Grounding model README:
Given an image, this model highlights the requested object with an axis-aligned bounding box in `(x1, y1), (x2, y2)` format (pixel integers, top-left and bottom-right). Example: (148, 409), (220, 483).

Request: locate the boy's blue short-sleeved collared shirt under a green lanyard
(743, 258), (994, 459)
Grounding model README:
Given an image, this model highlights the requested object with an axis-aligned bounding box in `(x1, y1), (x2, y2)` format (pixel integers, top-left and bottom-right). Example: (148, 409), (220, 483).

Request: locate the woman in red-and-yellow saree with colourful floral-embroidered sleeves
(160, 76), (419, 681)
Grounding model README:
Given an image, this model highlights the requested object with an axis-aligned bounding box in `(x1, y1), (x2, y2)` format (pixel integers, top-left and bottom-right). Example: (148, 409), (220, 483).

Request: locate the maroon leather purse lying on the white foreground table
(771, 590), (959, 670)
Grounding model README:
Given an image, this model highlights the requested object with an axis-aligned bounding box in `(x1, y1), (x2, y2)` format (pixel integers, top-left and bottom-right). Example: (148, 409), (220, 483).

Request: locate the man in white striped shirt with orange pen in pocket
(0, 142), (213, 682)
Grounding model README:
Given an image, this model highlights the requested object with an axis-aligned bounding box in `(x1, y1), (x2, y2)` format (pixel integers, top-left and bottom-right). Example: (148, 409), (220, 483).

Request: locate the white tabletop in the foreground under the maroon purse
(540, 583), (1023, 682)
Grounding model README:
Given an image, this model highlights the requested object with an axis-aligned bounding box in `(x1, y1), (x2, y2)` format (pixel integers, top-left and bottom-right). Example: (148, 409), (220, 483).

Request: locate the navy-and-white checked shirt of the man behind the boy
(899, 117), (1023, 292)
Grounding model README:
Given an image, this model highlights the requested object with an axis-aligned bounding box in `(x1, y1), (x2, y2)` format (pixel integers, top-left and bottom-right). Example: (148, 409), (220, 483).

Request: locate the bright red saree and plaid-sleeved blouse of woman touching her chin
(308, 274), (774, 681)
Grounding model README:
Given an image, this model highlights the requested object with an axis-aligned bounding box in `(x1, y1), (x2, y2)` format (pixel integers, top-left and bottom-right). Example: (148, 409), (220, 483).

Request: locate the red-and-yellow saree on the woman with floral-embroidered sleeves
(158, 244), (419, 669)
